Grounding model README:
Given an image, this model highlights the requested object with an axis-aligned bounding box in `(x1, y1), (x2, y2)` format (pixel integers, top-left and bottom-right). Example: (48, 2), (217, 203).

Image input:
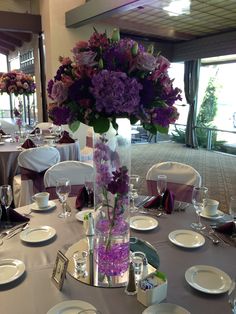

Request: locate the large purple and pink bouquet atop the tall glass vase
(47, 30), (181, 134)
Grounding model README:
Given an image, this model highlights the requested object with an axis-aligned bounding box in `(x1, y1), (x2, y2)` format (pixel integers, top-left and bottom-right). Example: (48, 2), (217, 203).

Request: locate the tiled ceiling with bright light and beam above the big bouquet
(66, 0), (236, 43)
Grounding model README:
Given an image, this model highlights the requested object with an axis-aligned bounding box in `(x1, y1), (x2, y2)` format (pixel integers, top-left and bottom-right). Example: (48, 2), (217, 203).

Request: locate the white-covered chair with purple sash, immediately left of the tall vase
(44, 160), (94, 199)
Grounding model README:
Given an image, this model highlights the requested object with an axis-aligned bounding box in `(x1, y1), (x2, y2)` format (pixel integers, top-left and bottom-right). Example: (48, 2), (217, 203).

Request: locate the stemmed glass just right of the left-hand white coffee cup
(56, 178), (71, 218)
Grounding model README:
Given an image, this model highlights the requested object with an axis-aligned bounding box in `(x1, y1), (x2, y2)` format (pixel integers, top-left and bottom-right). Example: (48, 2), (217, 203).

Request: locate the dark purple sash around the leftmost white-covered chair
(20, 167), (47, 193)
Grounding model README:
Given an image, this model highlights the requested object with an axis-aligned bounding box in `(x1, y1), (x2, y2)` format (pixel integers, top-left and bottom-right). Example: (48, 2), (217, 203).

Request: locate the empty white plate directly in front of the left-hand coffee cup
(20, 226), (56, 243)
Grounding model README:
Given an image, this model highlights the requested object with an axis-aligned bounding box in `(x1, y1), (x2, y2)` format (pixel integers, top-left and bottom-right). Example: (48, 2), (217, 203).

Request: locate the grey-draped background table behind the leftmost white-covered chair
(0, 139), (80, 185)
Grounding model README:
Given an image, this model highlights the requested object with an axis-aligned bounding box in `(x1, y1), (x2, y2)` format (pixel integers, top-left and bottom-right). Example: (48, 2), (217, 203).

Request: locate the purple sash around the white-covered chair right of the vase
(147, 180), (193, 203)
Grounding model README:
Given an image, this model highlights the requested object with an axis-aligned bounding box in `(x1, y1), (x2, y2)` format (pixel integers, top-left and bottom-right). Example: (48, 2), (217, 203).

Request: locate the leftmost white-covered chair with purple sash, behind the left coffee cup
(13, 147), (60, 207)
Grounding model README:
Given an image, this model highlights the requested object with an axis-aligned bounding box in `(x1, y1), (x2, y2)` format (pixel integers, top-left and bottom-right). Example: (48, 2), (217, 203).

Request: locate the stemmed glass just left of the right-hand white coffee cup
(191, 186), (208, 230)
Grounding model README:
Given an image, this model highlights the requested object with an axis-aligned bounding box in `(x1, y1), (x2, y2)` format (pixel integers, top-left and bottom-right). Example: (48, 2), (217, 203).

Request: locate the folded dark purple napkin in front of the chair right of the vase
(143, 189), (175, 214)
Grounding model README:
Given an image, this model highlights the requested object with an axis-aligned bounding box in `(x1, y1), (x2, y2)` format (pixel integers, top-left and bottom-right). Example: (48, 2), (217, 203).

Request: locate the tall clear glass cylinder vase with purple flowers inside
(94, 119), (131, 287)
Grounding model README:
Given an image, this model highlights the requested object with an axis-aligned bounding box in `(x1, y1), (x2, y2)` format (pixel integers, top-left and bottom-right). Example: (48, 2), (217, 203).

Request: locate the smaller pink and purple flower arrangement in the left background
(0, 71), (36, 96)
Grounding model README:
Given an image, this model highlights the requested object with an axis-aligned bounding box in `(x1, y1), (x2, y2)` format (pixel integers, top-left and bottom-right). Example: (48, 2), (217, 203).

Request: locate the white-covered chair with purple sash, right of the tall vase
(146, 161), (202, 203)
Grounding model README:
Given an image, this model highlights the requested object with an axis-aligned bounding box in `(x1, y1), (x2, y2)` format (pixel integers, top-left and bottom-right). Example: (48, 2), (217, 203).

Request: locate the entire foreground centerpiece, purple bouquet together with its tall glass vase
(48, 30), (181, 286)
